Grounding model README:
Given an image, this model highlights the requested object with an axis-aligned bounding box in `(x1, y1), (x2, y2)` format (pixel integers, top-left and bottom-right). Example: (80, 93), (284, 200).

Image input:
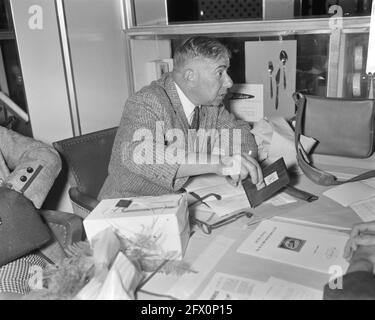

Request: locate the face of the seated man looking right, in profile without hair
(192, 58), (233, 106)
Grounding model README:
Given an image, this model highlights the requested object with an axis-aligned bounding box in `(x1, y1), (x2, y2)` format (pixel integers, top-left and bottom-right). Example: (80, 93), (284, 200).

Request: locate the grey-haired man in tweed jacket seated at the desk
(99, 37), (263, 199)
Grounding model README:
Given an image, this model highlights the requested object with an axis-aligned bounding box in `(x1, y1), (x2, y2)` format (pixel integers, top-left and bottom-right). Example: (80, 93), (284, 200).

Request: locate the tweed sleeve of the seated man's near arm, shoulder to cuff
(114, 95), (188, 191)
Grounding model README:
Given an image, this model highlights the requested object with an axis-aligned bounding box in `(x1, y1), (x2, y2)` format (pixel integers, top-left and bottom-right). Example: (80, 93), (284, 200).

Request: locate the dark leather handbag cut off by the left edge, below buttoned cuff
(0, 187), (51, 267)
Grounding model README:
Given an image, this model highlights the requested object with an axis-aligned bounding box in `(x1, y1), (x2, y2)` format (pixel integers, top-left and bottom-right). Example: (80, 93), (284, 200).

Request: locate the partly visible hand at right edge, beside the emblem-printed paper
(344, 221), (375, 260)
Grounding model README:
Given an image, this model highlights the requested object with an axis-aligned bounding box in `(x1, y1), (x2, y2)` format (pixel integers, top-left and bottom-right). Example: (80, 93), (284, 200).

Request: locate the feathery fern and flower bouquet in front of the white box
(24, 228), (195, 300)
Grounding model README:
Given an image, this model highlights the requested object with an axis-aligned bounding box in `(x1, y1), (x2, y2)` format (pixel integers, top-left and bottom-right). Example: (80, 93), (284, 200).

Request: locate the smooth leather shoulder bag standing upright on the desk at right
(293, 93), (375, 158)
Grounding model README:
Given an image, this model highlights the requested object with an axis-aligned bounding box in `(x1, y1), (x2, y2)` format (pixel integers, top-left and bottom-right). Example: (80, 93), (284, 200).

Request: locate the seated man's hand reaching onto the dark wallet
(217, 153), (263, 184)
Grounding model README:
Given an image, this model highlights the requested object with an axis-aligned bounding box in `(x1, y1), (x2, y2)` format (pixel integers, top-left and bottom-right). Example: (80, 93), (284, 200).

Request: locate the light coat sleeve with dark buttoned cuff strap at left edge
(0, 127), (61, 208)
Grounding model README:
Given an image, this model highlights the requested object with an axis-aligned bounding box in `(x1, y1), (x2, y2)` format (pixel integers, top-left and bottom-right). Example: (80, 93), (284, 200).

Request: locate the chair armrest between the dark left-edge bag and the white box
(39, 210), (83, 249)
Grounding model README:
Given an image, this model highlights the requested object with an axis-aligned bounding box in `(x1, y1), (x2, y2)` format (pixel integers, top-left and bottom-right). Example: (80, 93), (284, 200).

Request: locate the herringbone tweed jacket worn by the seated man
(99, 73), (257, 199)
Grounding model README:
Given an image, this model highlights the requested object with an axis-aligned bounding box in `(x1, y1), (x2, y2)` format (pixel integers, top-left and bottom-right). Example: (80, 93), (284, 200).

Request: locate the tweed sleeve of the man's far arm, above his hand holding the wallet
(217, 105), (258, 159)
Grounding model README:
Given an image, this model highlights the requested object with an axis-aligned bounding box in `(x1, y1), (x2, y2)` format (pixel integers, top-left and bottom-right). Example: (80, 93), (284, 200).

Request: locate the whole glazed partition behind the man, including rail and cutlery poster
(124, 0), (372, 116)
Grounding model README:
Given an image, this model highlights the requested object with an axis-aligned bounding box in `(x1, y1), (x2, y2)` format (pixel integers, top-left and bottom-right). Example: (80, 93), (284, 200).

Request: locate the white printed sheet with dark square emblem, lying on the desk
(237, 219), (349, 273)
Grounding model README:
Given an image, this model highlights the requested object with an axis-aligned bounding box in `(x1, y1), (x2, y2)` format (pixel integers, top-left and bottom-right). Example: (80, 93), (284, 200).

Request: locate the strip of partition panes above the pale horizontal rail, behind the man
(126, 0), (372, 26)
